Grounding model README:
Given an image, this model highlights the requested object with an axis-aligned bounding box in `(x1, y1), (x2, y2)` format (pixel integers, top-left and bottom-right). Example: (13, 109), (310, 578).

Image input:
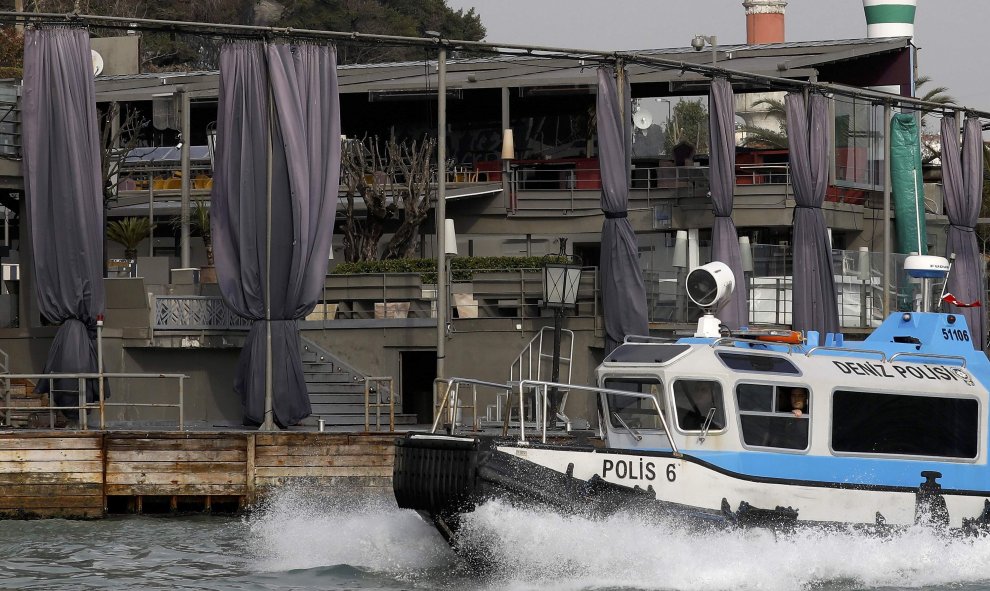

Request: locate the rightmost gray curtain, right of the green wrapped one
(942, 115), (987, 351)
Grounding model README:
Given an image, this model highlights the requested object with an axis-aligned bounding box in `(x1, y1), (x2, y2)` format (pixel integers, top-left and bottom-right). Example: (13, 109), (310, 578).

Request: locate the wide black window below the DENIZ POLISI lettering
(832, 390), (980, 459)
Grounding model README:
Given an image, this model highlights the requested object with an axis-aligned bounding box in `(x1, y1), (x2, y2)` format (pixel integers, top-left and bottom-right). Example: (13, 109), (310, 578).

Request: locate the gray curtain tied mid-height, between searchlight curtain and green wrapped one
(786, 93), (839, 336)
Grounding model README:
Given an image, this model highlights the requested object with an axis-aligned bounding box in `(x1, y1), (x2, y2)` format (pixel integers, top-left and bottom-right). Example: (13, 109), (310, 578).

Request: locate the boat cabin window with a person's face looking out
(736, 384), (811, 449)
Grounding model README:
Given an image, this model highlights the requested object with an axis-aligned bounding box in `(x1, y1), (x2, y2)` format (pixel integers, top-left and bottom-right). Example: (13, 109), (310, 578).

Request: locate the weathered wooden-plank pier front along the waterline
(0, 430), (396, 518)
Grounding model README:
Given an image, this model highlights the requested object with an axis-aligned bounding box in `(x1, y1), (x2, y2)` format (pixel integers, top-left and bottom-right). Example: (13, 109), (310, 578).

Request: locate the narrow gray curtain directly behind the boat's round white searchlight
(708, 78), (749, 328)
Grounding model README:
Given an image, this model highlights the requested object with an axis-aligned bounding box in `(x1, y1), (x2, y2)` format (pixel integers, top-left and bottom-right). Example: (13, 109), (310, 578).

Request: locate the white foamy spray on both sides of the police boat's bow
(248, 488), (990, 591)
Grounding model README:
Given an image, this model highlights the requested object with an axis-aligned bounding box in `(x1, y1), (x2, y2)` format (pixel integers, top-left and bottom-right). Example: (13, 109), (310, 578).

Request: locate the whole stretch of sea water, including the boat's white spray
(0, 488), (990, 591)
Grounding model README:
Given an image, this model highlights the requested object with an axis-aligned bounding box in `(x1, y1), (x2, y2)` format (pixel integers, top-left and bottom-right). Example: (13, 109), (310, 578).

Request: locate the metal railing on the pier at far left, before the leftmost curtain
(0, 373), (189, 431)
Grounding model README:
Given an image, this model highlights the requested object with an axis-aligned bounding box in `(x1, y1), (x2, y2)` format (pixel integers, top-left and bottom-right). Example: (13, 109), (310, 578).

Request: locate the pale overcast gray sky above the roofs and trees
(447, 0), (990, 111)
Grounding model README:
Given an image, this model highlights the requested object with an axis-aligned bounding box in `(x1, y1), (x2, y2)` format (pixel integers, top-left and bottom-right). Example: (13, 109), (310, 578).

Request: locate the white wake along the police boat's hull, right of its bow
(461, 502), (990, 591)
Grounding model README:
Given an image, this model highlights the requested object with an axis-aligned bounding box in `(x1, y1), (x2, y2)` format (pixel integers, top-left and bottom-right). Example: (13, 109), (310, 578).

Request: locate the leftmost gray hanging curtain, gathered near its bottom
(21, 28), (105, 414)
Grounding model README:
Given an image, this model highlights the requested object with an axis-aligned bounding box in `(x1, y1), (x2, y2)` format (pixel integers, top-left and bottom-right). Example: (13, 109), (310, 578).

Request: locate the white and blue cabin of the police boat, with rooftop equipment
(597, 257), (990, 475)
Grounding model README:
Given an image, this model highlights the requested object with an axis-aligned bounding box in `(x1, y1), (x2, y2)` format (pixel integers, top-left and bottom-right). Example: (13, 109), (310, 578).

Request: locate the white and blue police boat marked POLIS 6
(393, 256), (990, 548)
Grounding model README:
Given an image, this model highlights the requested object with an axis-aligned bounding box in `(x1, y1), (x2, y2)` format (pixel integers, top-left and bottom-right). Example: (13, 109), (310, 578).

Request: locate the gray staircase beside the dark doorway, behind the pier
(300, 337), (416, 430)
